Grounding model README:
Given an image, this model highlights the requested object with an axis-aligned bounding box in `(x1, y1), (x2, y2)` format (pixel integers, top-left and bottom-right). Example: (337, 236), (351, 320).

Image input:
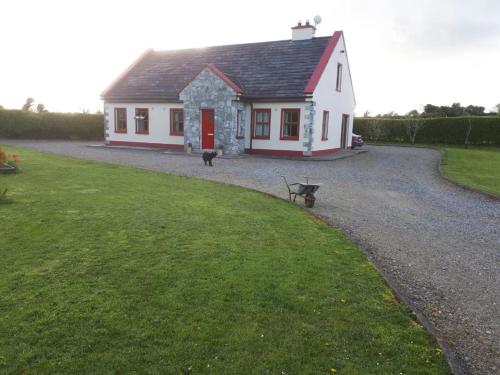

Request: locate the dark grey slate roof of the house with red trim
(103, 37), (330, 100)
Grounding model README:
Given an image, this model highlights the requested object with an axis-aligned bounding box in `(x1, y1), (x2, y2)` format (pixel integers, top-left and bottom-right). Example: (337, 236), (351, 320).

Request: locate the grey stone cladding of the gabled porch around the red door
(179, 69), (245, 154)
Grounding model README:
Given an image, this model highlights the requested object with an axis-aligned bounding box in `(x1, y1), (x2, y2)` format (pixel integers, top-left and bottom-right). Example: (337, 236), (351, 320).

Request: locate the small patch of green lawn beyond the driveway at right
(441, 146), (500, 196)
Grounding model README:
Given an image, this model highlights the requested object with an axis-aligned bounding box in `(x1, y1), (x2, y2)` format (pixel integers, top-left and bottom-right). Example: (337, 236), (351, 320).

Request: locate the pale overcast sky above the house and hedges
(0, 0), (500, 115)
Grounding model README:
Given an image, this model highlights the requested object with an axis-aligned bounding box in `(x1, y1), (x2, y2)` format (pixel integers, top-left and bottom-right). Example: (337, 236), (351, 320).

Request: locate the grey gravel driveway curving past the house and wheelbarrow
(0, 140), (500, 374)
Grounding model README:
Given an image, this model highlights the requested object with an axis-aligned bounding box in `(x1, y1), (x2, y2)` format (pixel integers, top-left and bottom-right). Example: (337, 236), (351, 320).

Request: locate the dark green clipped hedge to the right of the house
(354, 116), (500, 145)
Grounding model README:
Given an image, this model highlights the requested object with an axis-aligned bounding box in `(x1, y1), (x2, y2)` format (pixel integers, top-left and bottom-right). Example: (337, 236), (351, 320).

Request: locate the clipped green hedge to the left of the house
(0, 109), (104, 140)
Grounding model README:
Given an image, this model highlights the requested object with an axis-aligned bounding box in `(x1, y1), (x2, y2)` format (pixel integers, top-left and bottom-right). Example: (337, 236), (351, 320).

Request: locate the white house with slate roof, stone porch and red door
(102, 22), (355, 156)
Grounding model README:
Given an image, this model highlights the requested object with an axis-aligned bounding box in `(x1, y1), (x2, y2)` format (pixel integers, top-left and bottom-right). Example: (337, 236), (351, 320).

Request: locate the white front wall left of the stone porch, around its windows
(104, 103), (184, 145)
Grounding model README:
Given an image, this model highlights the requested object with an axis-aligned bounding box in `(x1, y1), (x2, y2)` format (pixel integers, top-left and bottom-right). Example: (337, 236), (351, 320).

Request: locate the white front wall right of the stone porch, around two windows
(245, 102), (307, 151)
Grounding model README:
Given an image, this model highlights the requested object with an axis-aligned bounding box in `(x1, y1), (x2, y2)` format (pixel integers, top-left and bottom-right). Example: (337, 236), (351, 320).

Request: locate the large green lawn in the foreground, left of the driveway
(0, 148), (450, 375)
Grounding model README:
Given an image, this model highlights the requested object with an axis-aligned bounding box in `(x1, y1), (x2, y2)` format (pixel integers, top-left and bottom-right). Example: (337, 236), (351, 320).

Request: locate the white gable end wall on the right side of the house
(312, 36), (355, 151)
